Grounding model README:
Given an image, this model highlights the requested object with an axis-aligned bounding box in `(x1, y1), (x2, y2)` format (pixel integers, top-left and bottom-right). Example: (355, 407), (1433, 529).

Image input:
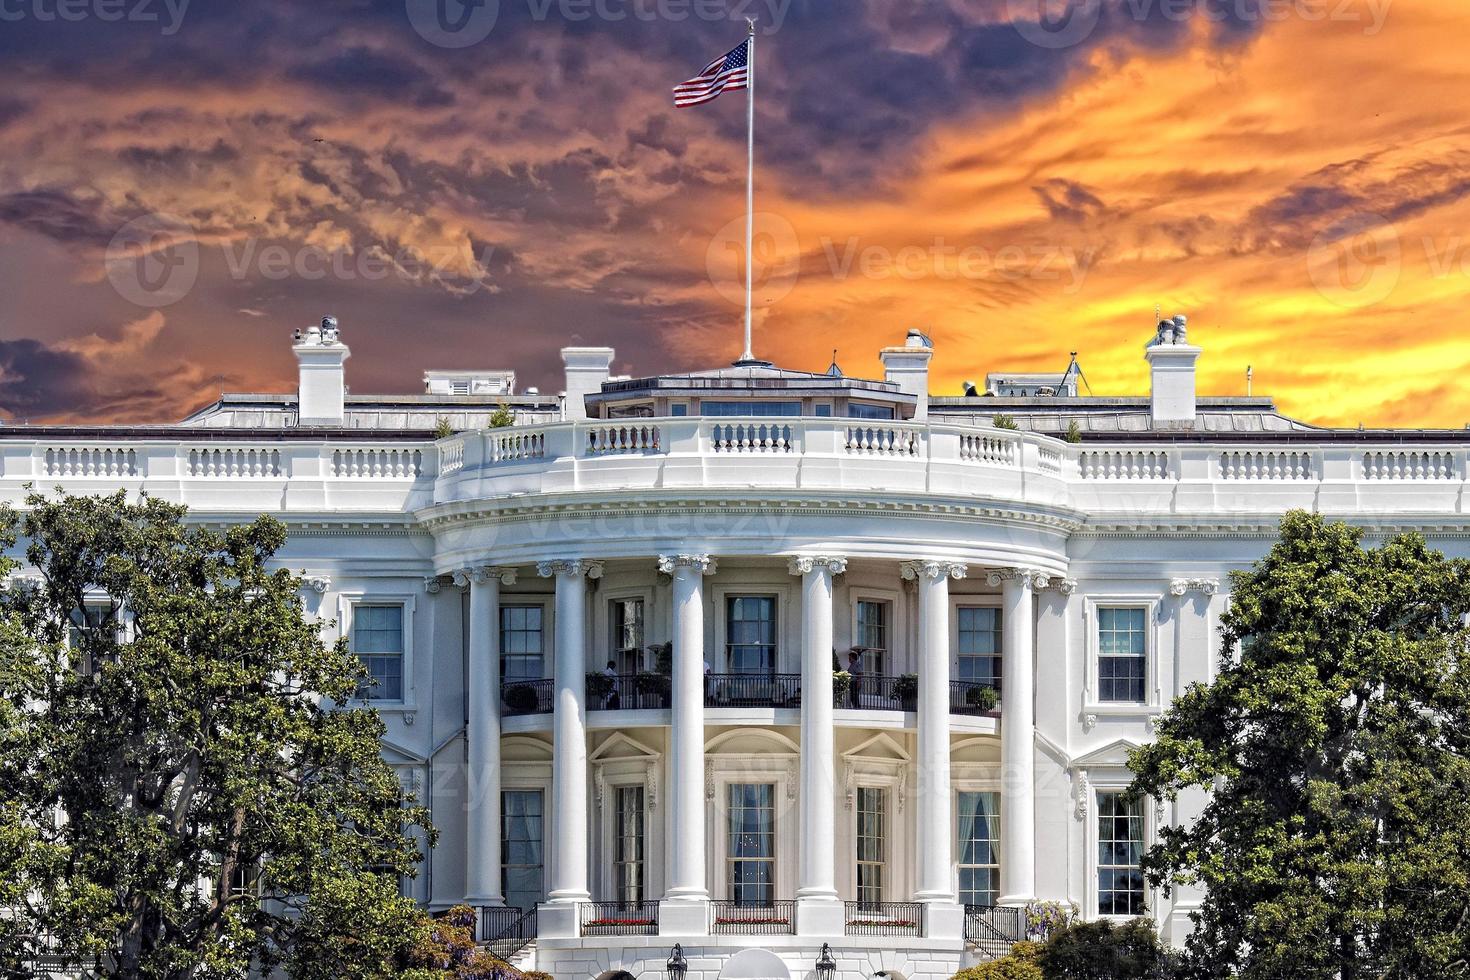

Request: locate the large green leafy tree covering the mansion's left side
(0, 494), (432, 980)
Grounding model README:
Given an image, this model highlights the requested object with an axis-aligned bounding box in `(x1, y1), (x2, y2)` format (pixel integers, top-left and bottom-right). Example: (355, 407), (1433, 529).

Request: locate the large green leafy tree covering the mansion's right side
(1130, 511), (1470, 980)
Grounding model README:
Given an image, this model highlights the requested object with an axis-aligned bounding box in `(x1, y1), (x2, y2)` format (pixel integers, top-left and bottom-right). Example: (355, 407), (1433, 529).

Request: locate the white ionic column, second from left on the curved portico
(537, 558), (603, 905)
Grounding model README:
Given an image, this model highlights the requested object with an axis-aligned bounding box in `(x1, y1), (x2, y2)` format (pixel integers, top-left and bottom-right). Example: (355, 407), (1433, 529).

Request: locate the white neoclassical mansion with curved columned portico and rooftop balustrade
(0, 317), (1470, 980)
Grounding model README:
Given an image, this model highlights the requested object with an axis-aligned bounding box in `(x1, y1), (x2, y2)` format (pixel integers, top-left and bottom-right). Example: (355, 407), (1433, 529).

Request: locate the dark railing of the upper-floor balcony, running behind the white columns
(500, 673), (1000, 718)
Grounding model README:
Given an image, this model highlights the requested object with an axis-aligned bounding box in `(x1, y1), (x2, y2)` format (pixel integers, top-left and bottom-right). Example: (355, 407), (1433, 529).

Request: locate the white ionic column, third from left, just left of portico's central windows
(659, 555), (714, 910)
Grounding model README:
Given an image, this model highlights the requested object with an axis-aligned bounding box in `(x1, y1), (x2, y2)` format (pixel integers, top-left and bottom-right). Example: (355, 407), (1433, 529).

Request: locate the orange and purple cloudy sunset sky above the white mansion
(0, 0), (1470, 428)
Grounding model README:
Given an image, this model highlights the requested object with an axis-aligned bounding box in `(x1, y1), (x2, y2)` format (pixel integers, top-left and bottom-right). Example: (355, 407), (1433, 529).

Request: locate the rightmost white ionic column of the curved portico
(988, 569), (1048, 905)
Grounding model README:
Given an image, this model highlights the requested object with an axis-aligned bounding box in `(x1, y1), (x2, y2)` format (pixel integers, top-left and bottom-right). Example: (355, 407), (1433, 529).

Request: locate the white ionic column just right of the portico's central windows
(789, 555), (847, 936)
